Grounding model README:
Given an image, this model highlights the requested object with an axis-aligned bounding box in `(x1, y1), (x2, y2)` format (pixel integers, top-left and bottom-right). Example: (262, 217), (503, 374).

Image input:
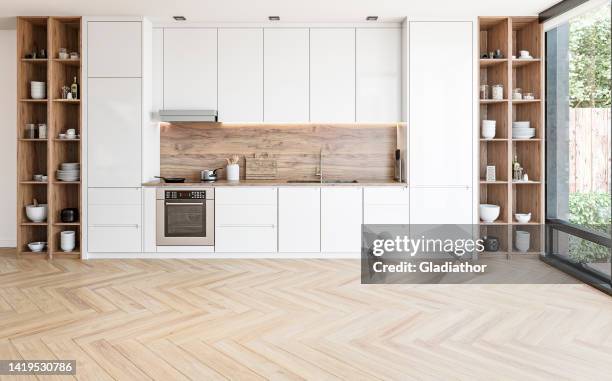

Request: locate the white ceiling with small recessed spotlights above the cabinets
(0, 0), (560, 22)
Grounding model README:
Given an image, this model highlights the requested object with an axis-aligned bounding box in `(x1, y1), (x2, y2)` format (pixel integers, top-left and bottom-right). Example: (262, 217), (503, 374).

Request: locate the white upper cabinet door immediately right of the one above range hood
(219, 28), (263, 122)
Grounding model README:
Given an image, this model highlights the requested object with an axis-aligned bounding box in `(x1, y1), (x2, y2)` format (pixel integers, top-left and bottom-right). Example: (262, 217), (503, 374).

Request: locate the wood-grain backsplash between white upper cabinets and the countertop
(160, 123), (398, 181)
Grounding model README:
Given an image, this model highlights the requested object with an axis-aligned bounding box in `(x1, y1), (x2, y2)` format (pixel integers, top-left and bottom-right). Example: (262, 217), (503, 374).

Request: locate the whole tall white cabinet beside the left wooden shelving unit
(83, 20), (145, 253)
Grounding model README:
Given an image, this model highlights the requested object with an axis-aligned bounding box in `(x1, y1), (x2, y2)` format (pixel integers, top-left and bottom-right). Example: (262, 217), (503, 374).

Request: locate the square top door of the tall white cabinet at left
(88, 21), (142, 77)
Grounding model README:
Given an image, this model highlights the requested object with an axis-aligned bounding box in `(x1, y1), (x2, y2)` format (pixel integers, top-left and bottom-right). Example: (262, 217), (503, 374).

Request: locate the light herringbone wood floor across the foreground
(0, 251), (612, 380)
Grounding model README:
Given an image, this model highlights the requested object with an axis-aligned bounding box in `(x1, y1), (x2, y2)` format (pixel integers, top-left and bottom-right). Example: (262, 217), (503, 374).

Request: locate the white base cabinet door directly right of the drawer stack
(278, 187), (321, 253)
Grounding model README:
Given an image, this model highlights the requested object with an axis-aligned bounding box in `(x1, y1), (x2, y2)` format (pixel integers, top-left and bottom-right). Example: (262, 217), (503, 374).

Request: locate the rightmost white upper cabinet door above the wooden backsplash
(356, 28), (402, 123)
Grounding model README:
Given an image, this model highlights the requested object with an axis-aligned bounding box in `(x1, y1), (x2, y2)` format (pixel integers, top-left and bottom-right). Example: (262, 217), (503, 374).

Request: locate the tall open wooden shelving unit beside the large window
(479, 17), (545, 252)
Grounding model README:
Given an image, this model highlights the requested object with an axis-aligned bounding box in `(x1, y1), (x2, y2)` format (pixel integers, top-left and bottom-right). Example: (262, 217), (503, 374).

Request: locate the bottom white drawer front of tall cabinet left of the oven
(87, 225), (142, 253)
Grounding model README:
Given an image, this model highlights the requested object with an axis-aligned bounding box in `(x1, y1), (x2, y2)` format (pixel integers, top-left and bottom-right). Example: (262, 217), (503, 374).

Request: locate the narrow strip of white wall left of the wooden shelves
(0, 30), (17, 247)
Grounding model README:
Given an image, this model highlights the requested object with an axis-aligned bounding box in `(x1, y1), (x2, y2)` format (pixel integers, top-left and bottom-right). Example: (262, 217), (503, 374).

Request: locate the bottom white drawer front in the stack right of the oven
(215, 225), (276, 253)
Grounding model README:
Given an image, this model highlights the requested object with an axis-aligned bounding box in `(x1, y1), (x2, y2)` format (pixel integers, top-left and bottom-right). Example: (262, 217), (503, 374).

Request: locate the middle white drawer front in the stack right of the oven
(215, 204), (276, 226)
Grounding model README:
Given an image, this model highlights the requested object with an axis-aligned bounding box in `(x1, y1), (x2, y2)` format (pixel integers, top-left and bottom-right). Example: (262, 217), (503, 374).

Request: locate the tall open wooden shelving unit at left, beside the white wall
(17, 17), (82, 259)
